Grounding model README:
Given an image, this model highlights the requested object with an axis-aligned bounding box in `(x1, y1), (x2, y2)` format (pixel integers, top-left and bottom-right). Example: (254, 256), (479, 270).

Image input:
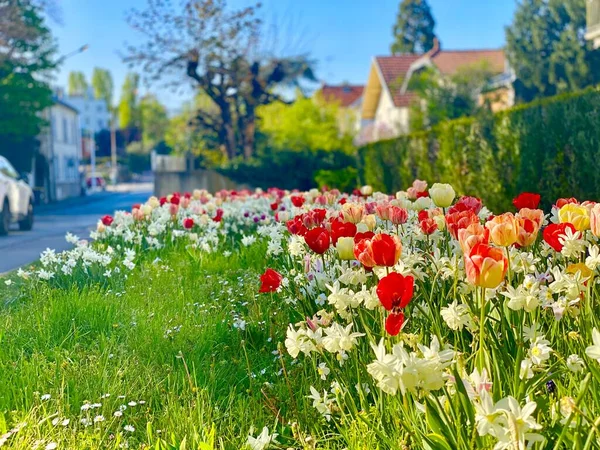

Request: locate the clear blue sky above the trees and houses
(50, 0), (516, 112)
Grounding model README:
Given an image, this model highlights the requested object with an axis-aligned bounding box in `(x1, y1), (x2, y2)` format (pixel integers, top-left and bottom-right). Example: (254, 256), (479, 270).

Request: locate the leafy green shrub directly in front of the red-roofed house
(408, 61), (493, 131)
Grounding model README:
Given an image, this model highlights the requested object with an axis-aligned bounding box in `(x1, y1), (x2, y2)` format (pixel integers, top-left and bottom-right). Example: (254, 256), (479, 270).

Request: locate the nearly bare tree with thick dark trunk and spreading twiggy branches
(126, 0), (316, 162)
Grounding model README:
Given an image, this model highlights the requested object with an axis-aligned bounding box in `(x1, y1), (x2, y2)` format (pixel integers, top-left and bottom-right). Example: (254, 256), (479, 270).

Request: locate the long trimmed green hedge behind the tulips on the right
(358, 88), (600, 211)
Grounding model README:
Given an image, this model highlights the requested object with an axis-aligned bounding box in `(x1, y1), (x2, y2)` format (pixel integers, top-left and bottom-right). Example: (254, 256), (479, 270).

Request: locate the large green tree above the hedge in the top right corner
(506, 0), (600, 101)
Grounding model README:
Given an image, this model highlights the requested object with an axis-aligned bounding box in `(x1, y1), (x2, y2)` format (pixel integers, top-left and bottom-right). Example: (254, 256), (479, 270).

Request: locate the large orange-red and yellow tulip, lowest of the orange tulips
(465, 244), (508, 289)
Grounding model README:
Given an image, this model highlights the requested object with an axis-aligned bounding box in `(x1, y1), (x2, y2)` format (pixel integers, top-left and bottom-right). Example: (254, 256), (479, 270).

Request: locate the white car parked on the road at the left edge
(0, 156), (33, 235)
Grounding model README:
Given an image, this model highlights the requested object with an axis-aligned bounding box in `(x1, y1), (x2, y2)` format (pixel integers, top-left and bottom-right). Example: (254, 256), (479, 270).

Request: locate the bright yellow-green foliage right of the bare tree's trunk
(257, 95), (354, 153)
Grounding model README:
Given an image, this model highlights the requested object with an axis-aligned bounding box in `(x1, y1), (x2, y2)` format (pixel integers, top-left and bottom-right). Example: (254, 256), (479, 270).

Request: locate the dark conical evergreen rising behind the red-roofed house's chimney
(391, 0), (435, 54)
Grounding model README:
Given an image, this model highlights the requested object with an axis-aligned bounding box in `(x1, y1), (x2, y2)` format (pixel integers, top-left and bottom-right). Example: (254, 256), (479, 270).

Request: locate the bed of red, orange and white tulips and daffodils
(0, 180), (600, 449)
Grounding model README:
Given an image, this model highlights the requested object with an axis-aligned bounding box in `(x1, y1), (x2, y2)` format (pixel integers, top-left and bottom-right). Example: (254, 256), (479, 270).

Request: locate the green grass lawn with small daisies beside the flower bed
(0, 244), (340, 449)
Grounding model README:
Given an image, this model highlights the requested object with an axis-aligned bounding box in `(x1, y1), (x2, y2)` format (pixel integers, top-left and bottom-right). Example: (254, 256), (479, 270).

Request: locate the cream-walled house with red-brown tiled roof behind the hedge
(359, 39), (514, 143)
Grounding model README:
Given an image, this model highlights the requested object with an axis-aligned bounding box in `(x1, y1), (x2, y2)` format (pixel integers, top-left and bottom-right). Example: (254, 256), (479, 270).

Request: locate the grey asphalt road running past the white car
(0, 184), (152, 274)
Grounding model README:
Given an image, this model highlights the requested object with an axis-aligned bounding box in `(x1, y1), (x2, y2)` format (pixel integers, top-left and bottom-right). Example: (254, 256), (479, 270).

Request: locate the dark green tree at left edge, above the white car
(0, 0), (56, 171)
